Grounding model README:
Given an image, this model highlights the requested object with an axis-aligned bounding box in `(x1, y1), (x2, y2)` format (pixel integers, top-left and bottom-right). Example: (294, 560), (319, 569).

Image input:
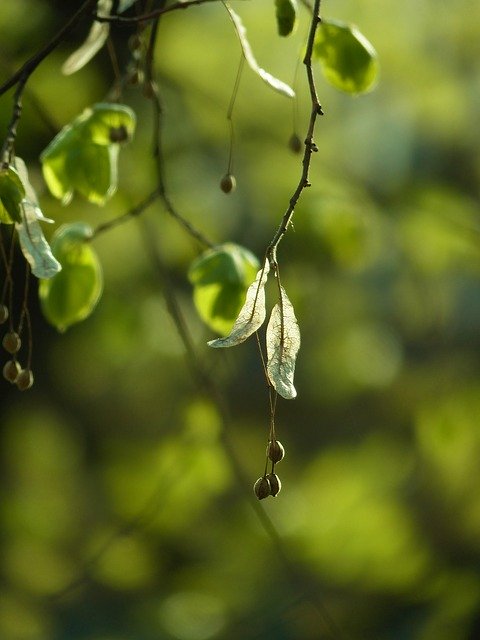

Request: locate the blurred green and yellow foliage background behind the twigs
(0, 0), (480, 640)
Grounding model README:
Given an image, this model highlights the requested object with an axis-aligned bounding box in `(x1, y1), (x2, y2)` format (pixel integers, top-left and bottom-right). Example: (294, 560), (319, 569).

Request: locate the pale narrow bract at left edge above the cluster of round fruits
(15, 157), (62, 278)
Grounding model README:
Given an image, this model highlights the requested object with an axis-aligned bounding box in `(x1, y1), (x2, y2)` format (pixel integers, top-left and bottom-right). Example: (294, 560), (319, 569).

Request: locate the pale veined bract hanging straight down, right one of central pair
(267, 287), (300, 400)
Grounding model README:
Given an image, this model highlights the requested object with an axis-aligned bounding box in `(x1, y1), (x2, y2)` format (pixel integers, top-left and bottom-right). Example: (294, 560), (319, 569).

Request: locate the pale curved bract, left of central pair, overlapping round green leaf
(208, 260), (270, 347)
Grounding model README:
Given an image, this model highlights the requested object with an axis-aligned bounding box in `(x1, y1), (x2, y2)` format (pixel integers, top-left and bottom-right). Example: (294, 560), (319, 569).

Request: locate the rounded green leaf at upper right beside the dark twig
(313, 20), (379, 94)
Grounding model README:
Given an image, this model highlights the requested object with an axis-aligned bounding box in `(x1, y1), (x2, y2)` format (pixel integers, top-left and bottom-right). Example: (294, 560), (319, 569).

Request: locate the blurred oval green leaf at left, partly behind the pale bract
(39, 223), (103, 331)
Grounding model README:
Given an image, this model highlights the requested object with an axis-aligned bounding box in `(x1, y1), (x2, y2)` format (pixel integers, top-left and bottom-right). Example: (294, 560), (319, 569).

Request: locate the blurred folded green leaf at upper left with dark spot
(40, 103), (135, 205)
